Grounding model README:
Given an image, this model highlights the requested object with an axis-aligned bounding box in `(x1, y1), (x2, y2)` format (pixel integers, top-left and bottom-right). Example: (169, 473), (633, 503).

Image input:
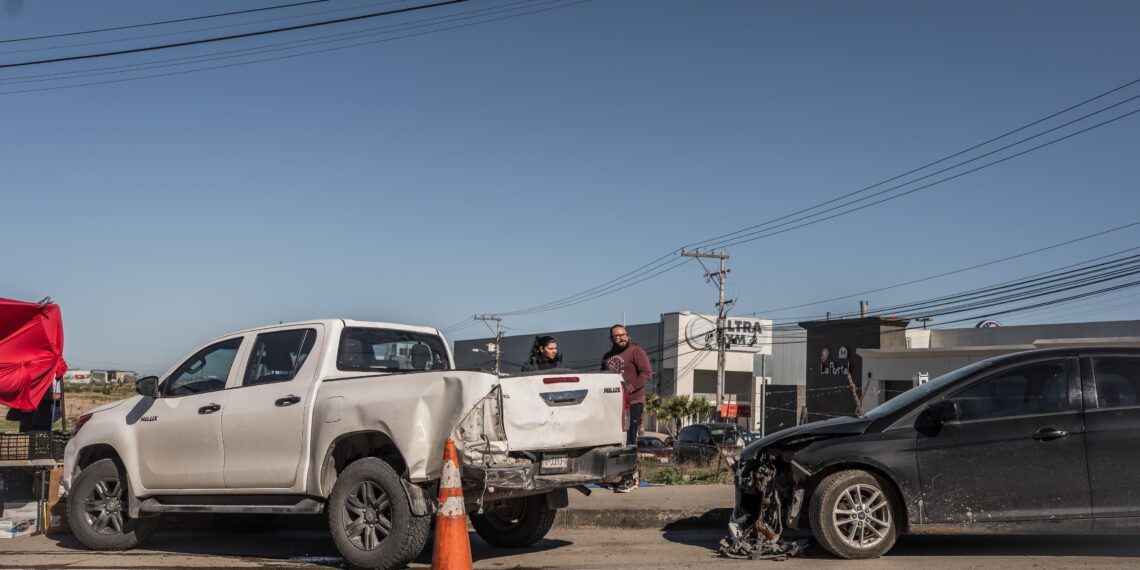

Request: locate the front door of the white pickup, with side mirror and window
(136, 336), (242, 489)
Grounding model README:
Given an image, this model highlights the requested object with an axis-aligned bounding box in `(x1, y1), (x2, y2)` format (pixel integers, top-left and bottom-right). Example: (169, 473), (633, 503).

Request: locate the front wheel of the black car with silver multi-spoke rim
(809, 470), (899, 560)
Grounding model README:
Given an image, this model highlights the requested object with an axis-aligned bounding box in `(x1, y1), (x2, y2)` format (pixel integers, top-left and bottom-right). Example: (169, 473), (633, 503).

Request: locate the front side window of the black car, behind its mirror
(951, 359), (1069, 421)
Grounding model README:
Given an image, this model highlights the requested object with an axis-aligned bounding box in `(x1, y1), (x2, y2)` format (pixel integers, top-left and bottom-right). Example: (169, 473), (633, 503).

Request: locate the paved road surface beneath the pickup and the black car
(0, 529), (1140, 570)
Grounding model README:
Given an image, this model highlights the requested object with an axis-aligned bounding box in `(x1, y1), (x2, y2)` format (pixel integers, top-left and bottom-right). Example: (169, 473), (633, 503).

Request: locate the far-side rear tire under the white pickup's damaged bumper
(471, 495), (557, 548)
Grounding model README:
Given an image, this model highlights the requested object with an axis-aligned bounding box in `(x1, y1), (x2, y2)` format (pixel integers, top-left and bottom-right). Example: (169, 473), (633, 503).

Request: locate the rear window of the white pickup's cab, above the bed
(336, 327), (449, 372)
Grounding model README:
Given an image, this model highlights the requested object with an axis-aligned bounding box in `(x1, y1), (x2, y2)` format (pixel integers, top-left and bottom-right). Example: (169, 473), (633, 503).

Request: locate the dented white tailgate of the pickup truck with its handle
(499, 373), (626, 451)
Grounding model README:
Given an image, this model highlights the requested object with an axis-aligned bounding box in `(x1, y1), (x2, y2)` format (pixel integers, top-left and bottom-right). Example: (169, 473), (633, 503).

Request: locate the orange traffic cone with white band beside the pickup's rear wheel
(431, 439), (471, 570)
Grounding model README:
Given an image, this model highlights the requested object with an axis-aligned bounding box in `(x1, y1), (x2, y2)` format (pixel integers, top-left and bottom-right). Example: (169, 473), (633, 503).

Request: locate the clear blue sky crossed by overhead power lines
(0, 0), (1140, 372)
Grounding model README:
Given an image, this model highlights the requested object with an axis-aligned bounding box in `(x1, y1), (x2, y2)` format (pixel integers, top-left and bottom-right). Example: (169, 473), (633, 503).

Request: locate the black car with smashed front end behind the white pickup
(725, 348), (1140, 559)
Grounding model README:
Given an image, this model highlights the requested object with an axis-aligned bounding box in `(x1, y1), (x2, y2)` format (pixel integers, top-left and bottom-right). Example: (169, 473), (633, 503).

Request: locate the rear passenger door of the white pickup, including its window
(221, 324), (324, 489)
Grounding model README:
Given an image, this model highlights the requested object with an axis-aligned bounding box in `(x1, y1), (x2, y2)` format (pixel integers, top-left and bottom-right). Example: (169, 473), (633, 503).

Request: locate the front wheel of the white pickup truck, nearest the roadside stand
(67, 459), (158, 551)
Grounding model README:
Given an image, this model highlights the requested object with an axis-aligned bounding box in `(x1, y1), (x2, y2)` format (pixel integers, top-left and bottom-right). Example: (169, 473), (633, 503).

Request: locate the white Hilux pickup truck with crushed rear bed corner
(64, 320), (637, 568)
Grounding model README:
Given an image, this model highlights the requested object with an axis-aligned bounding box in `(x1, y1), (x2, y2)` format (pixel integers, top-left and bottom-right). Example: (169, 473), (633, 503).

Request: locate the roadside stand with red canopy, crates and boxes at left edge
(0, 299), (67, 539)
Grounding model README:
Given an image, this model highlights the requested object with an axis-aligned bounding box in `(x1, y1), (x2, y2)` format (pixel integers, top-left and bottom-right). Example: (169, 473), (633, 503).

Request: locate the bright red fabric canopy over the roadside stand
(0, 299), (67, 410)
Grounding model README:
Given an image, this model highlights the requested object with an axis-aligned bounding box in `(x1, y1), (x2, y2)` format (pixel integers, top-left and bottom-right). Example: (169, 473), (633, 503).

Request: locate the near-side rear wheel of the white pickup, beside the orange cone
(328, 457), (431, 569)
